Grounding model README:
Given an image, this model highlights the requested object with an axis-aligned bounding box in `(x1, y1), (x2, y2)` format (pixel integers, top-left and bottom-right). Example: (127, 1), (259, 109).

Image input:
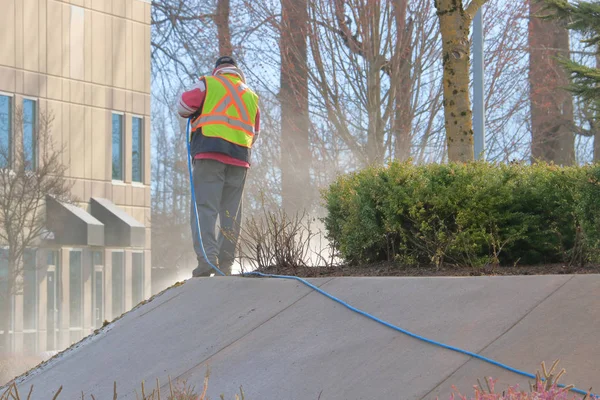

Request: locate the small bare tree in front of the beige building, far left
(0, 107), (73, 349)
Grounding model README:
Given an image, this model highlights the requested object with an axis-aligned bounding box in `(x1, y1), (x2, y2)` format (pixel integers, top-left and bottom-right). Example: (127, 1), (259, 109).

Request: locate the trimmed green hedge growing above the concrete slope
(323, 162), (600, 267)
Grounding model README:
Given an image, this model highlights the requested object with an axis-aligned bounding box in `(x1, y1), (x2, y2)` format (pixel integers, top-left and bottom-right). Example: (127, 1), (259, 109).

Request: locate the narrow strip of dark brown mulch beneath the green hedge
(255, 262), (600, 278)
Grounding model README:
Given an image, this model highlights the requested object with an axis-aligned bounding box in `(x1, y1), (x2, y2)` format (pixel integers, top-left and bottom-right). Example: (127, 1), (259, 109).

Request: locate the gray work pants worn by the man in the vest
(191, 160), (248, 275)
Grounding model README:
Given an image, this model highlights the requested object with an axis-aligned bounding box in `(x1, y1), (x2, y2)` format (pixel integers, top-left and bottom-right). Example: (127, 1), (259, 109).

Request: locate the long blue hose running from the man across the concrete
(187, 120), (600, 399)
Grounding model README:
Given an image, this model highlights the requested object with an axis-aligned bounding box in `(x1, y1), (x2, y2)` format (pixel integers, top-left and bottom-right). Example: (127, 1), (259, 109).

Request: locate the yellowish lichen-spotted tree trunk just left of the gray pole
(435, 0), (475, 162)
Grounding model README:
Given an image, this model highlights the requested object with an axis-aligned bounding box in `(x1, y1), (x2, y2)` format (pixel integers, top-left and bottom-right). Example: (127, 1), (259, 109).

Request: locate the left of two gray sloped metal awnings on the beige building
(46, 196), (104, 246)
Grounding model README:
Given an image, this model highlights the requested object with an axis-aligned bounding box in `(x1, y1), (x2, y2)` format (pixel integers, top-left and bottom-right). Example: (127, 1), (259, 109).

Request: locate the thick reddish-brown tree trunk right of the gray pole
(529, 0), (575, 165)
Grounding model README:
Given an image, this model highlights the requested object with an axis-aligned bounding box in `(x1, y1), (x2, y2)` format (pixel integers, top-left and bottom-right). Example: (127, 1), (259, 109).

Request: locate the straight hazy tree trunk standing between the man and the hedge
(279, 0), (311, 213)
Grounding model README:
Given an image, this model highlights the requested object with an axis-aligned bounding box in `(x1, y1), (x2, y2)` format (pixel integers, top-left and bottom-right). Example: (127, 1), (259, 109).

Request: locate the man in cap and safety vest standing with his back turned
(178, 56), (260, 277)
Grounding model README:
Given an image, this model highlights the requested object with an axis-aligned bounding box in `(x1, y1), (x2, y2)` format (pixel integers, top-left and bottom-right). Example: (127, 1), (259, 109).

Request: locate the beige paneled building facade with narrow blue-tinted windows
(0, 0), (151, 354)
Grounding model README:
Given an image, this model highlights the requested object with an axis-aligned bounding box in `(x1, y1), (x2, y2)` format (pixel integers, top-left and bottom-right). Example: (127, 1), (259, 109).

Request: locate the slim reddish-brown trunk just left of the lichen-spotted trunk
(393, 0), (412, 161)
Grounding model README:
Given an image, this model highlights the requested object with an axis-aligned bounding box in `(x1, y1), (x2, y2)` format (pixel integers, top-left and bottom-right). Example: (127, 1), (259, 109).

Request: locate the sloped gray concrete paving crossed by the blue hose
(10, 275), (600, 400)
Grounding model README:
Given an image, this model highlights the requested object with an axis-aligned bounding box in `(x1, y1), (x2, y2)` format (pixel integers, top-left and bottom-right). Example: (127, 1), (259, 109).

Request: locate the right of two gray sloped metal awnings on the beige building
(90, 197), (146, 247)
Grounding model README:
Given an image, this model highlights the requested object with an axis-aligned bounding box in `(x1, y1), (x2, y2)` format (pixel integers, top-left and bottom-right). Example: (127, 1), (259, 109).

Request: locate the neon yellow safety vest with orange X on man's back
(190, 75), (258, 149)
